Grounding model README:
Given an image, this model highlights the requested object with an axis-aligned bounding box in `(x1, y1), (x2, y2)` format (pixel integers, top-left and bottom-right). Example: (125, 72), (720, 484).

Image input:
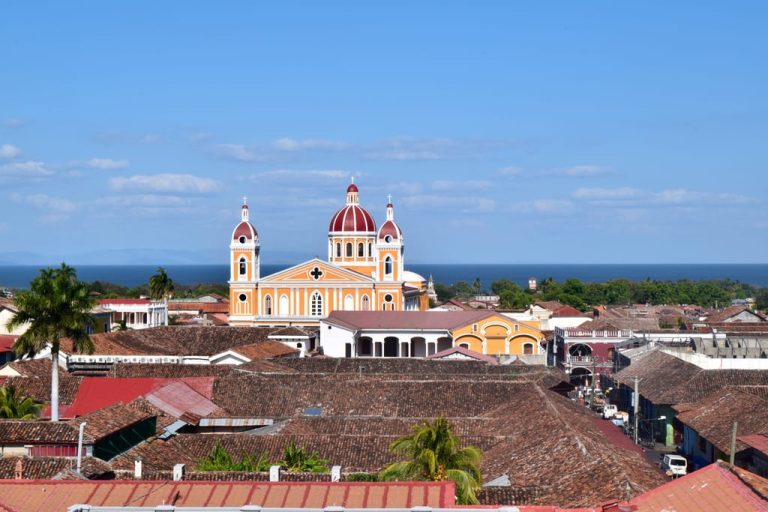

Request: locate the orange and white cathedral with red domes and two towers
(229, 182), (429, 326)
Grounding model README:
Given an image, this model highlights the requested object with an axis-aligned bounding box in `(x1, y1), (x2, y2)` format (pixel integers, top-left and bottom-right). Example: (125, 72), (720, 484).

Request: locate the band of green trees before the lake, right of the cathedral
(435, 277), (768, 311)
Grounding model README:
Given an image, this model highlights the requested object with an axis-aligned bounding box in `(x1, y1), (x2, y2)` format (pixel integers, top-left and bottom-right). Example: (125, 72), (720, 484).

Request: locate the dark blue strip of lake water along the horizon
(0, 264), (768, 288)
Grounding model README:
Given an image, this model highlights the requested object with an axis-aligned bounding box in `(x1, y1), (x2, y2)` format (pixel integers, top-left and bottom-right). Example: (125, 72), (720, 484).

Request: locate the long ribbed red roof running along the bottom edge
(0, 481), (455, 510)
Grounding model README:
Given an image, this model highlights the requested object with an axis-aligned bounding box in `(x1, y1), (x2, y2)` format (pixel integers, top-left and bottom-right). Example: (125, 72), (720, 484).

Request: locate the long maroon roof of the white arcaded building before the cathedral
(326, 310), (496, 330)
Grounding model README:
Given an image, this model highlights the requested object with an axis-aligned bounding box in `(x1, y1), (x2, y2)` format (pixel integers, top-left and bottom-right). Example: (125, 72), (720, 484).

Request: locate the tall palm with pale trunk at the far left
(8, 263), (96, 421)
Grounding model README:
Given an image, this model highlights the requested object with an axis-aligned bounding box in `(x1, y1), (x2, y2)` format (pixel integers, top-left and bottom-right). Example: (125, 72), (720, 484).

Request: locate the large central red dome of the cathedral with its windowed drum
(328, 179), (376, 277)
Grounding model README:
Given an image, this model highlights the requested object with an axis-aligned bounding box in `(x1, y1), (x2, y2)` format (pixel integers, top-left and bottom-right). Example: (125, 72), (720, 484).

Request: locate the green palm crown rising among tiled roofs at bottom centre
(380, 417), (483, 505)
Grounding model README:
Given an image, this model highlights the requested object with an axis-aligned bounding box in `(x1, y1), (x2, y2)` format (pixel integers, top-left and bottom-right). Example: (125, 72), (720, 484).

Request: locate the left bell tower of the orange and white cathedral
(229, 198), (260, 317)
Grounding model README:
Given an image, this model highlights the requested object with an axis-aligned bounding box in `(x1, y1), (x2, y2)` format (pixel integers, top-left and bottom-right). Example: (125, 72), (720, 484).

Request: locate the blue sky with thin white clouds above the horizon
(0, 1), (768, 264)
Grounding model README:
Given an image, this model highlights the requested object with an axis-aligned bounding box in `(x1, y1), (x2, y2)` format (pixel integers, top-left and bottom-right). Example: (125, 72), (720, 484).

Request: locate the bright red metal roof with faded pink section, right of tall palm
(68, 377), (213, 417)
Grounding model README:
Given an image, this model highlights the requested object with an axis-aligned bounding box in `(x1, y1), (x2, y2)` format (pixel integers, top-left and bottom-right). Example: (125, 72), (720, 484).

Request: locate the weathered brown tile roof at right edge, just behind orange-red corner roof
(677, 386), (768, 454)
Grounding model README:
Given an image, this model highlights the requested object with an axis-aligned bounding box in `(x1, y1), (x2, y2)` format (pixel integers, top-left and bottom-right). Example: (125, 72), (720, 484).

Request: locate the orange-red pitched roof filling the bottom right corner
(629, 461), (768, 512)
